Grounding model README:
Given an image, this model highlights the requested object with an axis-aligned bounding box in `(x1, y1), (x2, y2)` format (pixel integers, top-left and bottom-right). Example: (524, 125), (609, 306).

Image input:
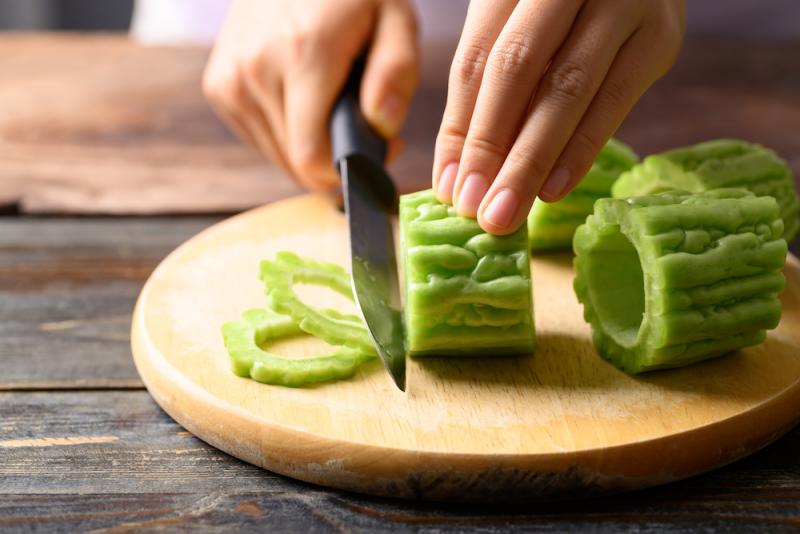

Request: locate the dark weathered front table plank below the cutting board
(0, 391), (800, 532)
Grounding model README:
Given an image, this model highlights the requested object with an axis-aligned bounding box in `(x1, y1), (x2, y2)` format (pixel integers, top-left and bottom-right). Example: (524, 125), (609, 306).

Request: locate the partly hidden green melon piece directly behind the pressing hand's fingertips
(528, 139), (639, 251)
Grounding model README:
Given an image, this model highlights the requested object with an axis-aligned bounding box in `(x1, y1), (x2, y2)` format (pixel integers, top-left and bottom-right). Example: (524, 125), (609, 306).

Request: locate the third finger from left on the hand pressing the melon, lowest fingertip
(478, 2), (641, 234)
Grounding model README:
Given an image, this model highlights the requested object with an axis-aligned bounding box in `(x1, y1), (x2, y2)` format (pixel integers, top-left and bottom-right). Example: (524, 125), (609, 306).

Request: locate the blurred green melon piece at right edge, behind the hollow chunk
(612, 139), (800, 242)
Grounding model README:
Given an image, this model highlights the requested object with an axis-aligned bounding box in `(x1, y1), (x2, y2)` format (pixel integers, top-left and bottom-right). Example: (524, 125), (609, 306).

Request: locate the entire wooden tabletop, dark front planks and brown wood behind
(0, 36), (800, 532)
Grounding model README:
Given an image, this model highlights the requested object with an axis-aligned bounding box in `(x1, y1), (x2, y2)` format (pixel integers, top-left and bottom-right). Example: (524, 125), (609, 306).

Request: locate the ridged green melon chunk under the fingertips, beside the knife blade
(400, 190), (535, 356)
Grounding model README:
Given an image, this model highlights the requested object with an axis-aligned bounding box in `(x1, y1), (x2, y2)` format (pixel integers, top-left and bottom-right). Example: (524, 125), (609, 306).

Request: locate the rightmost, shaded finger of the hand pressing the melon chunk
(539, 15), (680, 202)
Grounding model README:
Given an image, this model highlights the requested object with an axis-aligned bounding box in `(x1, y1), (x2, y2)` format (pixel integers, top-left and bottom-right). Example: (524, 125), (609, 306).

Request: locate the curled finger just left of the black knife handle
(284, 0), (375, 190)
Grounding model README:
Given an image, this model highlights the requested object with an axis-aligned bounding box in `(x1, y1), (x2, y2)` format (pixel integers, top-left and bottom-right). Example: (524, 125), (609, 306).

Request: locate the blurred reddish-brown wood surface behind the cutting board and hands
(0, 34), (800, 214)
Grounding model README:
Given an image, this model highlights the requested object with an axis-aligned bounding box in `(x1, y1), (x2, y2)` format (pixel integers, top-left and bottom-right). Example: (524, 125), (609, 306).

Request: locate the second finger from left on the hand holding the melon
(453, 0), (580, 217)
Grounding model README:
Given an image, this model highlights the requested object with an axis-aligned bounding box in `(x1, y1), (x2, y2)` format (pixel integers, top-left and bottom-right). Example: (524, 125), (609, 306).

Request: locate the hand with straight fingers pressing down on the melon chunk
(433, 0), (685, 234)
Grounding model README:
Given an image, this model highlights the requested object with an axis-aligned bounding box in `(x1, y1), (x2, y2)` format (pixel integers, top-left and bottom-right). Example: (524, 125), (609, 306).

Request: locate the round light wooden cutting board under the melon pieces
(132, 196), (800, 501)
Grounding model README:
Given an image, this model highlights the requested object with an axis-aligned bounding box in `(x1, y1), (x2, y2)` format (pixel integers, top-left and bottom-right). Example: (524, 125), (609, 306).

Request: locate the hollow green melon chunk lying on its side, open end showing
(573, 189), (787, 373)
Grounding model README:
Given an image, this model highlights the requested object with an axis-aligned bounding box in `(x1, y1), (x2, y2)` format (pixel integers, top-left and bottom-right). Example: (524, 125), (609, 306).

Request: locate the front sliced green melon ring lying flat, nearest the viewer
(222, 308), (374, 387)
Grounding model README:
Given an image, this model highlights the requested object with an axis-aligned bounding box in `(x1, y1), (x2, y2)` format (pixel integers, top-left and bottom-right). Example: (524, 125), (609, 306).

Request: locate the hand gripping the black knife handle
(203, 0), (418, 190)
